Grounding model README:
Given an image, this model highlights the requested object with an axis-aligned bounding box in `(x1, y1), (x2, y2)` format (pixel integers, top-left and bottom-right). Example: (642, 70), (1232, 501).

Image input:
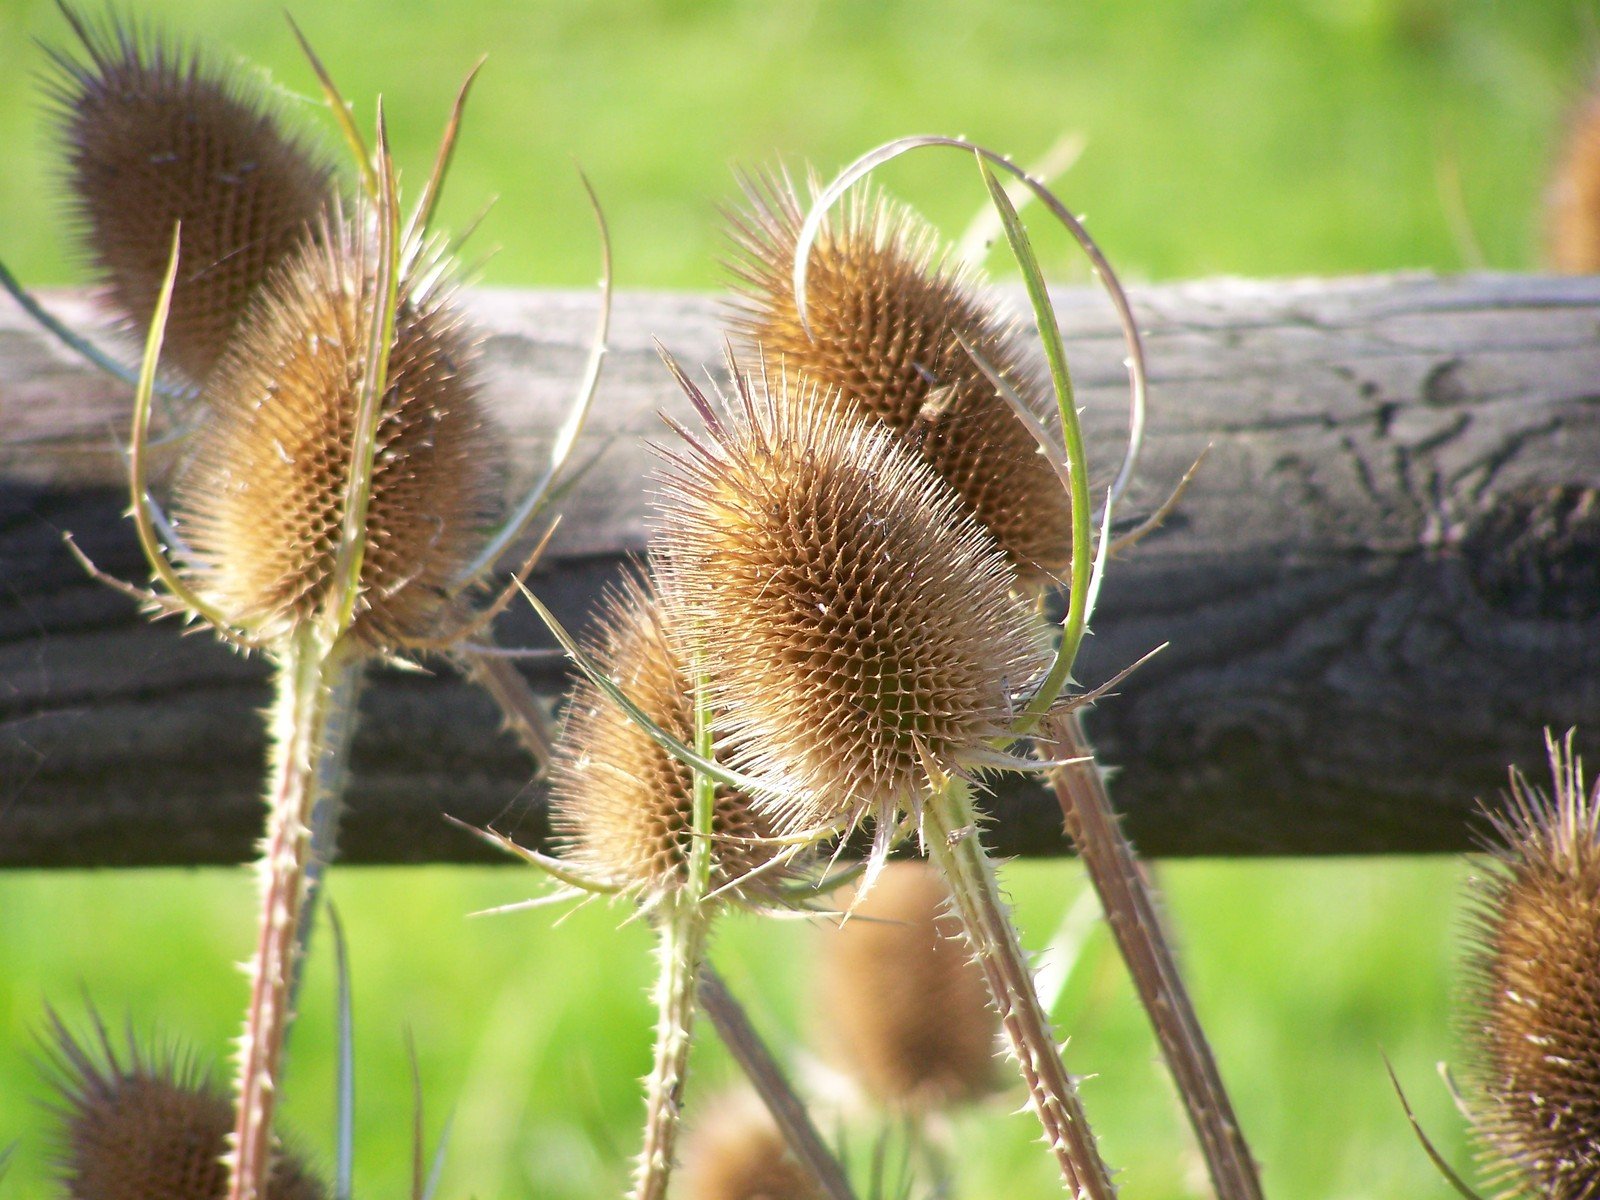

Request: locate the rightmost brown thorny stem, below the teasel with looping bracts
(1042, 712), (1261, 1200)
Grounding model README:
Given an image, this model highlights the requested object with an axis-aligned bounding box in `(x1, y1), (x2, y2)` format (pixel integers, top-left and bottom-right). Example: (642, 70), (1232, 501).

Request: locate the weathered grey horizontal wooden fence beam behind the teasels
(0, 277), (1600, 866)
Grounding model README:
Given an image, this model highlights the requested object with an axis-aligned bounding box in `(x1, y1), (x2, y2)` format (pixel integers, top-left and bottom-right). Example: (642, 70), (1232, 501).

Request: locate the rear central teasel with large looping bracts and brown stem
(710, 138), (1259, 1197)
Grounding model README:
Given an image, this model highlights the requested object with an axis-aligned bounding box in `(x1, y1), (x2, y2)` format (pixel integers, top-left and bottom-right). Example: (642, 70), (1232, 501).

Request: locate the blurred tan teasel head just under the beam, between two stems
(818, 862), (1000, 1112)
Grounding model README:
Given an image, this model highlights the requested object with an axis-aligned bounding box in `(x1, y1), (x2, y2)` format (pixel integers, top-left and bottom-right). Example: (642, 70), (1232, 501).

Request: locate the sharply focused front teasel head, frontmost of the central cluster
(659, 371), (1045, 838)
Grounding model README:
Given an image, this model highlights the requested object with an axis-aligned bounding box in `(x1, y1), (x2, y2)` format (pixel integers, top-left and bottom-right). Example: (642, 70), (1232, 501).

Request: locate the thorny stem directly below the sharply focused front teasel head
(922, 778), (1117, 1200)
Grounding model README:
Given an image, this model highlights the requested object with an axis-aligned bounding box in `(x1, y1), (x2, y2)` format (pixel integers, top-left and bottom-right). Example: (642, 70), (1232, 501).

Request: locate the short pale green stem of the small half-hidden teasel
(632, 896), (709, 1200)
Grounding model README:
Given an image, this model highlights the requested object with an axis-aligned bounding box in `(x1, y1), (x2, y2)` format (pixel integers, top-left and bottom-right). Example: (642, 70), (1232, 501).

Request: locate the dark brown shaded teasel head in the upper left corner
(51, 10), (333, 384)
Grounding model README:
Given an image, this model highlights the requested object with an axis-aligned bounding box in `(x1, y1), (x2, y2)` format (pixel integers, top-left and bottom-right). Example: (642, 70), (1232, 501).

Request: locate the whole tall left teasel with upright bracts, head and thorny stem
(42, 29), (610, 1200)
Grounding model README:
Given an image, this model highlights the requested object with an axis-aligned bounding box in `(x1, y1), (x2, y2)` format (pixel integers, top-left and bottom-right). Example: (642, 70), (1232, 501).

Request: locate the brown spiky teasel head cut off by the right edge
(1469, 738), (1600, 1200)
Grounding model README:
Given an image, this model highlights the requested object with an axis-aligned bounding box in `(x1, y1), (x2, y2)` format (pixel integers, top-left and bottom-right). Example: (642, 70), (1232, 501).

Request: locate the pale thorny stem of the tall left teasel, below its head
(227, 626), (350, 1200)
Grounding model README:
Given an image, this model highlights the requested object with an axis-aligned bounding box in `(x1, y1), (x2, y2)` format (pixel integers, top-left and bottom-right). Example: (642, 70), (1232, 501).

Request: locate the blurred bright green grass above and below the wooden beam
(0, 0), (1595, 1200)
